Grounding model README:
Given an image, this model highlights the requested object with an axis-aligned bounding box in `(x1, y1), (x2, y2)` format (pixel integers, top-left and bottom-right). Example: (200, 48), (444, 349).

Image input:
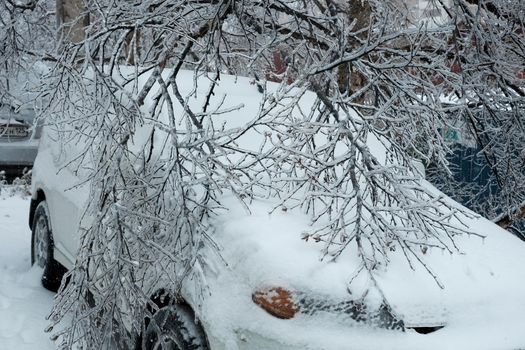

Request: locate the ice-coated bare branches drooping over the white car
(35, 0), (492, 348)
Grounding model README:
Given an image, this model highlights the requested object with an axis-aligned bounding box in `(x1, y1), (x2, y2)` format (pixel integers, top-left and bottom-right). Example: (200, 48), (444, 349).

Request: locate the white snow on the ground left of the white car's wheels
(0, 195), (55, 350)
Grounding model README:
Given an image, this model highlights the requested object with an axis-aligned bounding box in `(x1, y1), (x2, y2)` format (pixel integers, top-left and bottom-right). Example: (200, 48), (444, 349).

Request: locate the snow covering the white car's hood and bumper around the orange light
(195, 191), (525, 350)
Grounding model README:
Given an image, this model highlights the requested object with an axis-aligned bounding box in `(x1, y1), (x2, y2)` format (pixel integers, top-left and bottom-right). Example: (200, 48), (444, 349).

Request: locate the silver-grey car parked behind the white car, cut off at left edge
(0, 108), (40, 178)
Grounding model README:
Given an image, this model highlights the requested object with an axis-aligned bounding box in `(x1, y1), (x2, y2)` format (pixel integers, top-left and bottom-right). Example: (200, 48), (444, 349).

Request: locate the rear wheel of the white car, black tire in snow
(31, 201), (66, 292)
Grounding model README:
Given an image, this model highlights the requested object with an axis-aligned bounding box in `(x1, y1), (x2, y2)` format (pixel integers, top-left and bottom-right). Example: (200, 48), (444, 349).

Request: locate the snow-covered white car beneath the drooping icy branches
(29, 72), (525, 350)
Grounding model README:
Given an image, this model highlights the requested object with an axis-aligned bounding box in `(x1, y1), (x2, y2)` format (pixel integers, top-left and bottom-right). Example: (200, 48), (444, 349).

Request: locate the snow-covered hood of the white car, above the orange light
(206, 191), (525, 326)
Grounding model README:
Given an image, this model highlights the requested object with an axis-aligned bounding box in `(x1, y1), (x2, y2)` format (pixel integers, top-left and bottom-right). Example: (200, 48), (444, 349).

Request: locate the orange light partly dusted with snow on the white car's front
(252, 287), (299, 320)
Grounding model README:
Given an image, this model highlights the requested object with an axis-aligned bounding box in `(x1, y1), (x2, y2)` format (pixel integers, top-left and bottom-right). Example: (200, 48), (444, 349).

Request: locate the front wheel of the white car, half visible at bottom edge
(143, 304), (208, 350)
